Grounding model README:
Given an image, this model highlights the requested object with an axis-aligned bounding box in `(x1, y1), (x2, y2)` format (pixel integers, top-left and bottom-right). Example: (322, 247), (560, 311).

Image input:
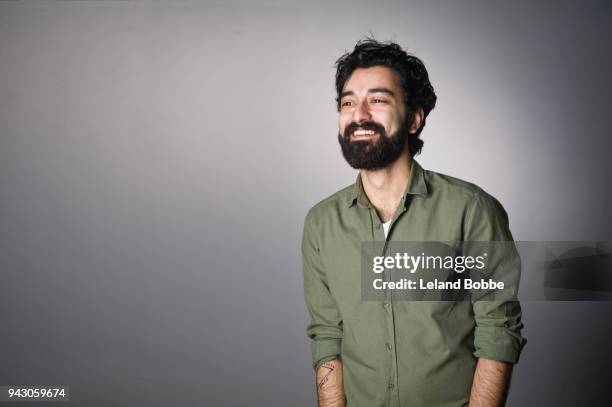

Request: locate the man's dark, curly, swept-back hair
(334, 38), (437, 157)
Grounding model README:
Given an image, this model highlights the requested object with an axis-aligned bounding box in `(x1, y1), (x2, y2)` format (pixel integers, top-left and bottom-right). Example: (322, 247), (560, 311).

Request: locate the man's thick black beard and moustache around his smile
(338, 121), (409, 170)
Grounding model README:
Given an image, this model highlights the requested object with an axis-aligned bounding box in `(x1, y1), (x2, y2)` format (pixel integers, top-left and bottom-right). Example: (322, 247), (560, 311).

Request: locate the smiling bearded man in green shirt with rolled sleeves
(302, 39), (525, 407)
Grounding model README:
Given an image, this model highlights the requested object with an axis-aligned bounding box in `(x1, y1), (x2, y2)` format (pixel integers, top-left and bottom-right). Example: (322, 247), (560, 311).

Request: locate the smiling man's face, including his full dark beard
(338, 66), (414, 170)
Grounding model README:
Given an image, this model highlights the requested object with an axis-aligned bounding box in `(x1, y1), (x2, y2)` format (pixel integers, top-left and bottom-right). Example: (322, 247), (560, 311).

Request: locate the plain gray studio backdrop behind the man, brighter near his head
(0, 0), (612, 406)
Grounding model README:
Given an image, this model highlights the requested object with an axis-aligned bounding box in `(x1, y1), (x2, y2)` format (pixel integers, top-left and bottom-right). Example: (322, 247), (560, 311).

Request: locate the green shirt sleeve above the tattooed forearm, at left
(302, 214), (342, 369)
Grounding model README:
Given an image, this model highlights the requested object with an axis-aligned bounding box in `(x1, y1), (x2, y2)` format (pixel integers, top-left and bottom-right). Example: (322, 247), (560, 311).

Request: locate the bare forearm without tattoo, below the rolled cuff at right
(470, 358), (512, 407)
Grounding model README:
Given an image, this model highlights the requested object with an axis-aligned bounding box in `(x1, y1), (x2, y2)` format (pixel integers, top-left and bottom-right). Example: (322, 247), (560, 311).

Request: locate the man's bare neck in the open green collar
(360, 151), (412, 222)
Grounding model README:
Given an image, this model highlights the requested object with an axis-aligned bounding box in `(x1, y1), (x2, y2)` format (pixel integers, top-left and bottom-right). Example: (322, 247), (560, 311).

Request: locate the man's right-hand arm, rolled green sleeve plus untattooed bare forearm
(465, 196), (526, 407)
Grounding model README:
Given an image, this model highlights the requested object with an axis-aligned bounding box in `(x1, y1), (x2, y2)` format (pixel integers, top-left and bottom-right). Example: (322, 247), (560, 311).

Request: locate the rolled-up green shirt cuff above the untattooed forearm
(474, 326), (527, 363)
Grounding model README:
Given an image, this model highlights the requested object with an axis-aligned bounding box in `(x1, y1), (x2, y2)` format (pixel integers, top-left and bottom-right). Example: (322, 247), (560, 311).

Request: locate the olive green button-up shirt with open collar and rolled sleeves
(302, 161), (525, 407)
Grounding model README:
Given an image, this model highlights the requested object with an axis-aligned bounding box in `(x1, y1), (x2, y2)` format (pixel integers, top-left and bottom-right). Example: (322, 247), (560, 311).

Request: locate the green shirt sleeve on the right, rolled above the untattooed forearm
(464, 195), (526, 363)
